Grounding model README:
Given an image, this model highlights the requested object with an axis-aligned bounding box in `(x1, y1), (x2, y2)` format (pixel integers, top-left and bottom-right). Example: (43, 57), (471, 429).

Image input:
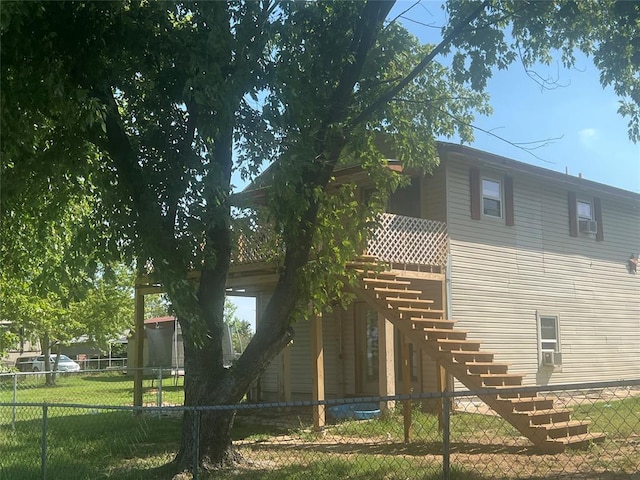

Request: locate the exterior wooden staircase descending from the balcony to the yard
(351, 258), (605, 453)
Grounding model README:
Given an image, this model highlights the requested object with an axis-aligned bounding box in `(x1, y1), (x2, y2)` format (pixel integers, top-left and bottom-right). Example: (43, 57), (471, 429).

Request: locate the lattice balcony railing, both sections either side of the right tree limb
(232, 213), (449, 268)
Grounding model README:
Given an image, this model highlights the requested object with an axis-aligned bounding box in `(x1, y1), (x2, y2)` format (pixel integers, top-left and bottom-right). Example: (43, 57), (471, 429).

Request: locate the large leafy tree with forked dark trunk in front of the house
(0, 1), (637, 468)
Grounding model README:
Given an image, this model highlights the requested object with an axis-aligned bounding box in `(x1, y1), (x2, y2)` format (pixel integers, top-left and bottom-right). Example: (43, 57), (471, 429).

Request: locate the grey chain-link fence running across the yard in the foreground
(0, 374), (640, 480)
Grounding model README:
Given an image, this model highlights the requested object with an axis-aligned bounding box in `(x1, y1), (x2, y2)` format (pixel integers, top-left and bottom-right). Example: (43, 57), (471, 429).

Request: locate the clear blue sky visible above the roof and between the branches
(228, 0), (640, 334)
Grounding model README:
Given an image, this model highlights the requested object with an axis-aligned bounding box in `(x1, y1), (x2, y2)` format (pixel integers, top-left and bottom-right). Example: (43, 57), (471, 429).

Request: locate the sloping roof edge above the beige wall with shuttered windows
(437, 142), (640, 202)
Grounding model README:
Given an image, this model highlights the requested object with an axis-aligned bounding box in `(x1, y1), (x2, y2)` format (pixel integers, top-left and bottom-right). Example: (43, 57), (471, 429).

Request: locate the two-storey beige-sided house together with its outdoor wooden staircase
(134, 143), (640, 450)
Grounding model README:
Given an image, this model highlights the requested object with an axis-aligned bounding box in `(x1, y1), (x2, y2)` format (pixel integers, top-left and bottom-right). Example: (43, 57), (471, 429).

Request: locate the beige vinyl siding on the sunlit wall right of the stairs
(447, 161), (640, 384)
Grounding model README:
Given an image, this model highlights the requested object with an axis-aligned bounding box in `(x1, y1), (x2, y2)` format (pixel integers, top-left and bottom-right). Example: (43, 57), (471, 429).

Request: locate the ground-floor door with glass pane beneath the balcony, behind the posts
(355, 303), (380, 395)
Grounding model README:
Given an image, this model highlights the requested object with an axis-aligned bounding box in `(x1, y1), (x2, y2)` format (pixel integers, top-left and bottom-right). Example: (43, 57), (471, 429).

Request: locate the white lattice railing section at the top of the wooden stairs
(367, 213), (449, 267)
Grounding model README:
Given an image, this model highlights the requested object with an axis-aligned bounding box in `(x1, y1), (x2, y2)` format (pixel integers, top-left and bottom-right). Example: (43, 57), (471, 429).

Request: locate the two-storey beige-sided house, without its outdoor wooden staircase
(241, 143), (640, 400)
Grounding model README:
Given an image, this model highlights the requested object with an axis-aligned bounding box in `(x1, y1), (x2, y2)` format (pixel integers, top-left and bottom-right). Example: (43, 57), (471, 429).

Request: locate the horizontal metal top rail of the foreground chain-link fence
(0, 379), (640, 413)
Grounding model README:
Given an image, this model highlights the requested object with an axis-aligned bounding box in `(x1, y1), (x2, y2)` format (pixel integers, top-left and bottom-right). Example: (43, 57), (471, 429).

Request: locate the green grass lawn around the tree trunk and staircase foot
(0, 382), (640, 480)
